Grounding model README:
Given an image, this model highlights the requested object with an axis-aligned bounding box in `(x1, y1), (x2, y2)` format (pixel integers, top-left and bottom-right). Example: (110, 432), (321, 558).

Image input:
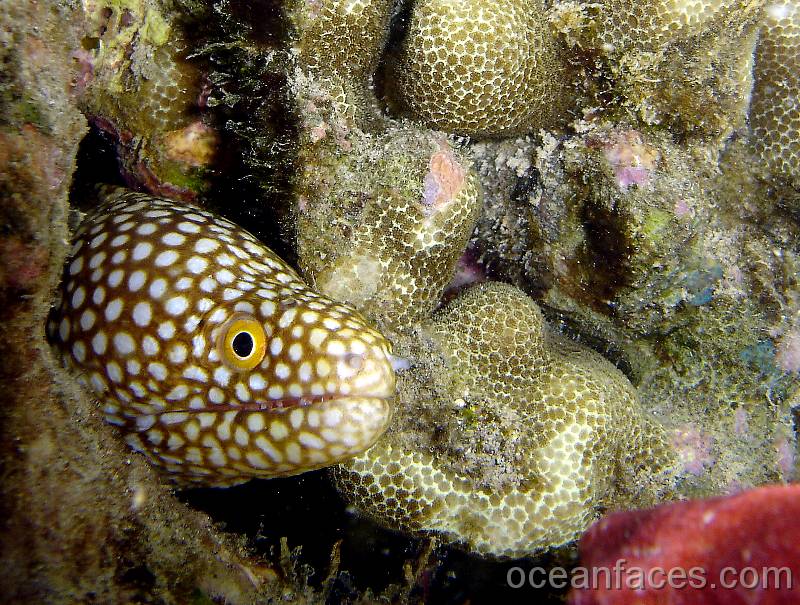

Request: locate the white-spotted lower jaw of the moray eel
(125, 395), (392, 486)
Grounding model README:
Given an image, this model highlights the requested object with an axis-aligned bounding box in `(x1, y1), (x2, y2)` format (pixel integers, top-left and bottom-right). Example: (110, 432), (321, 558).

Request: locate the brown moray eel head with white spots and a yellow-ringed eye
(48, 190), (395, 486)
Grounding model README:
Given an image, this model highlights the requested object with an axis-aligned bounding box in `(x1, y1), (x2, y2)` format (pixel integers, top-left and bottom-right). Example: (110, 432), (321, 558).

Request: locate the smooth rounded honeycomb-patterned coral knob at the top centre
(389, 0), (569, 137)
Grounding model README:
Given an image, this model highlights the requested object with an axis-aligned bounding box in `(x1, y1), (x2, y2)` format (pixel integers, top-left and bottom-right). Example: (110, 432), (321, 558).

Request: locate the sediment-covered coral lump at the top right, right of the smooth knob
(579, 0), (763, 145)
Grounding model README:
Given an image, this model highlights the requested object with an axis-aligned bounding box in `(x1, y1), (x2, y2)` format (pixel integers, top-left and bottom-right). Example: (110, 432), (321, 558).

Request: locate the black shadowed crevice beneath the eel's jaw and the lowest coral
(178, 471), (576, 605)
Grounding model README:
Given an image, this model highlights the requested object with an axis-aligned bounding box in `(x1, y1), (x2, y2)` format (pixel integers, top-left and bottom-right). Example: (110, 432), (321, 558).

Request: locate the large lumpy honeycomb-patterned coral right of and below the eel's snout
(334, 282), (674, 557)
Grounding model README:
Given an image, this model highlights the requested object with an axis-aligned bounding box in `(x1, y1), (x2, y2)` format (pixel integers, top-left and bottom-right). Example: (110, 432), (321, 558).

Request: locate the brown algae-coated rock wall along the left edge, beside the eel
(0, 2), (288, 603)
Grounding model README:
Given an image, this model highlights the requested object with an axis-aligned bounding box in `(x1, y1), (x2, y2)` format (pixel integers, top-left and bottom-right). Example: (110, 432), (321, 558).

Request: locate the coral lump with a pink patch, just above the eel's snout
(298, 132), (481, 326)
